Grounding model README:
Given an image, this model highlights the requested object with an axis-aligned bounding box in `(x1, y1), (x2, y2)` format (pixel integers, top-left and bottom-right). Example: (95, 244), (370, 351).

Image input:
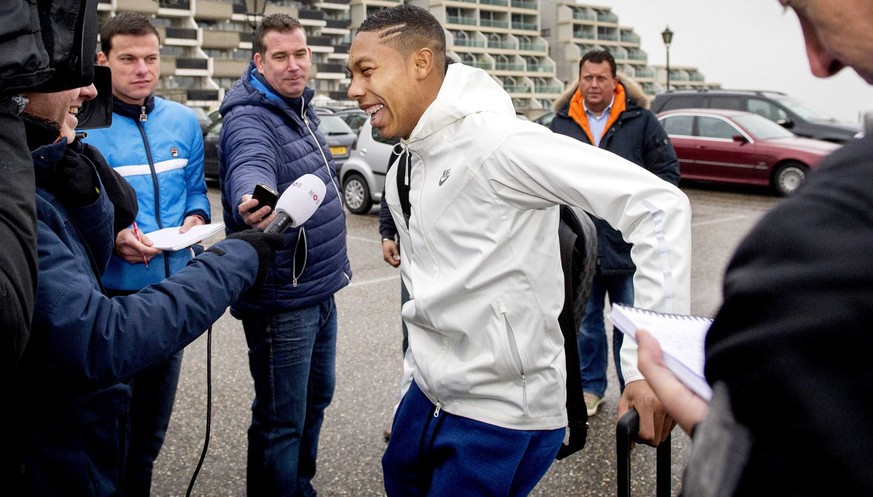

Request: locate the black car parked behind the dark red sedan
(651, 90), (861, 143)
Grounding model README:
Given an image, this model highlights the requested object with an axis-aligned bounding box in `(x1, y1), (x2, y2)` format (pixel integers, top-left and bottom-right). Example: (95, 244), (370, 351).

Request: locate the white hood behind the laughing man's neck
(409, 63), (515, 142)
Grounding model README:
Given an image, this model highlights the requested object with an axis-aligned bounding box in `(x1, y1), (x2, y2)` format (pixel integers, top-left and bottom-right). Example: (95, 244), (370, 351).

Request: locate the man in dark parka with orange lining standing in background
(549, 49), (679, 416)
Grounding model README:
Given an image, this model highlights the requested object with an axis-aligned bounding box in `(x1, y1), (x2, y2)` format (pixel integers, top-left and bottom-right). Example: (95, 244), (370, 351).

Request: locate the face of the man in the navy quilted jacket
(254, 29), (312, 98)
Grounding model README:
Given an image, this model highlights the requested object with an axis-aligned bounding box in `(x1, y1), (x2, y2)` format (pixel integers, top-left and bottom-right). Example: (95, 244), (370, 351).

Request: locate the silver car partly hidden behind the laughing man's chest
(339, 119), (397, 214)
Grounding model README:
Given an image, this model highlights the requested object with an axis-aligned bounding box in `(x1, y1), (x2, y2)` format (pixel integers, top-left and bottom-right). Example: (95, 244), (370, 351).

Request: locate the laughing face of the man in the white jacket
(348, 31), (439, 138)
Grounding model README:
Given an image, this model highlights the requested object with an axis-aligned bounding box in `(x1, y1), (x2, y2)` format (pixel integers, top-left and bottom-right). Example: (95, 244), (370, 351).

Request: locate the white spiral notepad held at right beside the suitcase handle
(609, 304), (712, 401)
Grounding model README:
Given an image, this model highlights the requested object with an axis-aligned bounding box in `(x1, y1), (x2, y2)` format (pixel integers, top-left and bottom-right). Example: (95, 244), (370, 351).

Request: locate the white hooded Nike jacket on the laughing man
(385, 64), (691, 430)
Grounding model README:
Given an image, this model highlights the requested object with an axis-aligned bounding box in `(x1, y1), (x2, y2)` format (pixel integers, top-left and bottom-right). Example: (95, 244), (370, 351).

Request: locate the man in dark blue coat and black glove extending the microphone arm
(11, 78), (281, 496)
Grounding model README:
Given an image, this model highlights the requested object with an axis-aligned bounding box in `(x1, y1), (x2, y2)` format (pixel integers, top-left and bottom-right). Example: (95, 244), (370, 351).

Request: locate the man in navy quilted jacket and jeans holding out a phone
(219, 14), (352, 496)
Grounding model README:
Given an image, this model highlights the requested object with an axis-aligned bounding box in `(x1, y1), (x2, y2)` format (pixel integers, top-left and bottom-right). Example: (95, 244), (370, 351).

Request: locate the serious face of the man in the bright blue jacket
(97, 33), (161, 105)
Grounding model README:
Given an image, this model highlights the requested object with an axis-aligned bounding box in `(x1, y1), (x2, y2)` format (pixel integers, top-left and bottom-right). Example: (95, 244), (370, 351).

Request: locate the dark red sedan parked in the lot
(658, 109), (840, 196)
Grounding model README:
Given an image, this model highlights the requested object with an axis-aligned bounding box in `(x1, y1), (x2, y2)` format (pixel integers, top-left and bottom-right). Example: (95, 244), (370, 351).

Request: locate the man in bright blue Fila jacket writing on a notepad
(87, 12), (210, 496)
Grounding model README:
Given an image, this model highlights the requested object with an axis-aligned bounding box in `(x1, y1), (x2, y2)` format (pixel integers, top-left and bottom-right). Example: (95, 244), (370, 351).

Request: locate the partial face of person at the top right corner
(780, 0), (873, 84)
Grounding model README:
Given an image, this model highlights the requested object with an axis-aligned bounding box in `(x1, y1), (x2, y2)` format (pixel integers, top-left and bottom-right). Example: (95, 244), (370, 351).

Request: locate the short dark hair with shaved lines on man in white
(358, 4), (448, 75)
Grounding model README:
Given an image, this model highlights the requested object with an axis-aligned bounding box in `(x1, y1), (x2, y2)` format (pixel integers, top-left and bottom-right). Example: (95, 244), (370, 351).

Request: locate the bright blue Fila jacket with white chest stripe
(85, 96), (210, 290)
